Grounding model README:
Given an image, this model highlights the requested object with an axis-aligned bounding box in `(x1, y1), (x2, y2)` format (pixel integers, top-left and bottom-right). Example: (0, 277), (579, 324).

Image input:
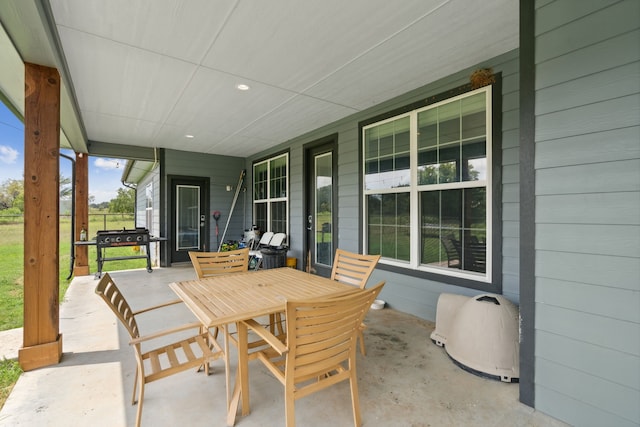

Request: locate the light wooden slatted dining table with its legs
(169, 267), (359, 426)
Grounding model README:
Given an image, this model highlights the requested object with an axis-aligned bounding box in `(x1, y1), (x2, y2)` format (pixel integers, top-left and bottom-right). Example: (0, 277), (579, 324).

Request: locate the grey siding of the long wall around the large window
(246, 51), (519, 320)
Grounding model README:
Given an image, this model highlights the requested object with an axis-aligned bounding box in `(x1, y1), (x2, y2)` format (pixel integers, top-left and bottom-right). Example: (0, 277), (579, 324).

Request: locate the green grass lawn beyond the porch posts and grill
(0, 214), (146, 330)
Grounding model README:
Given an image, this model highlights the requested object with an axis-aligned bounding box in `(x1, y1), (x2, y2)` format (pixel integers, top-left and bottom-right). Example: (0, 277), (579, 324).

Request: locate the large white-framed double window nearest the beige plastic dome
(362, 86), (492, 282)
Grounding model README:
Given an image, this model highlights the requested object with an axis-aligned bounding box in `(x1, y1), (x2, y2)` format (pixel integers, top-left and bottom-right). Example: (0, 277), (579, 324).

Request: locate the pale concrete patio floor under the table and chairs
(0, 265), (565, 427)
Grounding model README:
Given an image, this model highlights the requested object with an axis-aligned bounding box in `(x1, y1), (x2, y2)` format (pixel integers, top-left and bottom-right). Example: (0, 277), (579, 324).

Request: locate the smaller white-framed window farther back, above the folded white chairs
(253, 153), (289, 234)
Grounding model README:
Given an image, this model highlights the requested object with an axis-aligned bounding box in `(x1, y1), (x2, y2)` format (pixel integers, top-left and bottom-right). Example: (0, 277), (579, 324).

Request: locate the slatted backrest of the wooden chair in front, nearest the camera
(285, 282), (384, 384)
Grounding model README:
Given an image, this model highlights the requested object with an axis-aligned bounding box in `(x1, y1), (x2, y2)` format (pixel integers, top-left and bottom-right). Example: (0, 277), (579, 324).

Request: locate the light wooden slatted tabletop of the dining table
(169, 267), (358, 327)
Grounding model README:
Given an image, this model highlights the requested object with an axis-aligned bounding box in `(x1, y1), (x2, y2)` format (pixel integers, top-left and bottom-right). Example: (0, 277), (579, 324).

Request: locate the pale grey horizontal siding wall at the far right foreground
(535, 0), (640, 426)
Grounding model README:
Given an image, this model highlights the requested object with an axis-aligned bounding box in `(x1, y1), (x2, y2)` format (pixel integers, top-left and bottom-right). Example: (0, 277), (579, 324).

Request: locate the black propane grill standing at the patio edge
(96, 228), (153, 277)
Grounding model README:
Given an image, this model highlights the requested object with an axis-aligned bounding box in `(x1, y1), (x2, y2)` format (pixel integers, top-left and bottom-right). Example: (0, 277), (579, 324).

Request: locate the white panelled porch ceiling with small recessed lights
(2, 0), (518, 157)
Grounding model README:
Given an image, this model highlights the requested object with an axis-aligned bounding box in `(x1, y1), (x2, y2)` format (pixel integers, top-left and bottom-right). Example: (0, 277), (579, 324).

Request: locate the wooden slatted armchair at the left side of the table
(95, 273), (226, 426)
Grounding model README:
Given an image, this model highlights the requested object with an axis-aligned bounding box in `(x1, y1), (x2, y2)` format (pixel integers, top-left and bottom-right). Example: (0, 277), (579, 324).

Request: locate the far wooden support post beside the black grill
(73, 153), (91, 276)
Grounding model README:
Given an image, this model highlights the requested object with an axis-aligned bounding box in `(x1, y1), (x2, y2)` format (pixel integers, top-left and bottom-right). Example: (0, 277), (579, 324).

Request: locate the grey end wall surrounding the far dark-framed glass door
(162, 150), (246, 251)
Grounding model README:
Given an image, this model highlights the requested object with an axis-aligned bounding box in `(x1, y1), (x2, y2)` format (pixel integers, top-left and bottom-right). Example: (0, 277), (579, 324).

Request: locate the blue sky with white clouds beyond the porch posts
(0, 101), (126, 203)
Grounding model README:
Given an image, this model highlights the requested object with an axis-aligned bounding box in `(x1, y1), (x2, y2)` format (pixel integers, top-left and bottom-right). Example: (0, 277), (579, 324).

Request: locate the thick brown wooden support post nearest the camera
(18, 63), (62, 371)
